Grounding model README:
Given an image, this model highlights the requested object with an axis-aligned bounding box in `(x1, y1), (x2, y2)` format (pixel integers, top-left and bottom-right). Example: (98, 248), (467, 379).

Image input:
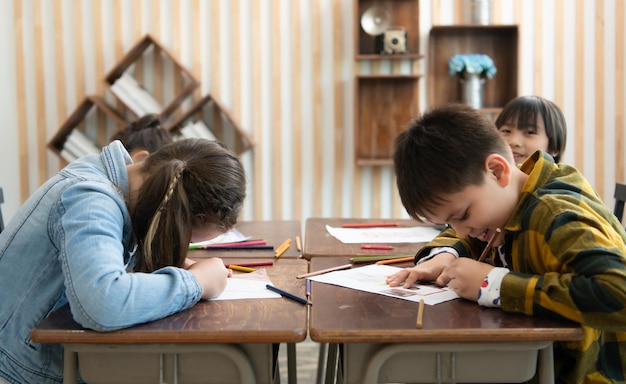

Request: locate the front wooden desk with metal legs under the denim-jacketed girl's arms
(31, 259), (307, 384)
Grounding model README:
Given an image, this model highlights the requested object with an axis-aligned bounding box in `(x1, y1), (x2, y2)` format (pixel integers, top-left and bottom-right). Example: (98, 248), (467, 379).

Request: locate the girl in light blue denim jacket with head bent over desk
(0, 139), (246, 383)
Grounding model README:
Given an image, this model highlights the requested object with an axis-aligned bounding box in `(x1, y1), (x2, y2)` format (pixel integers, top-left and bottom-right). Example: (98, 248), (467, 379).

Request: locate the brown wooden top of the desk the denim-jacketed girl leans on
(31, 258), (307, 344)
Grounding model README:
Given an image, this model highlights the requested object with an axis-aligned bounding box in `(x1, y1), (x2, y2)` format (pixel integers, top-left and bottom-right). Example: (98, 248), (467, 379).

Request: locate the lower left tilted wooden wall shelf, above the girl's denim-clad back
(48, 95), (128, 162)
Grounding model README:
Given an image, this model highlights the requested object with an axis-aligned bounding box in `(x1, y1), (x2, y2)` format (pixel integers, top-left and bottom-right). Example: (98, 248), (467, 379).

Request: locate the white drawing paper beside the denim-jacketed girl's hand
(212, 269), (281, 300)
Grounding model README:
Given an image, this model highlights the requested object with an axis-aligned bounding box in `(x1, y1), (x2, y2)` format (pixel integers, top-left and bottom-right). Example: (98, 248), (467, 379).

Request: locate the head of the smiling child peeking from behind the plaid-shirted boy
(496, 96), (567, 164)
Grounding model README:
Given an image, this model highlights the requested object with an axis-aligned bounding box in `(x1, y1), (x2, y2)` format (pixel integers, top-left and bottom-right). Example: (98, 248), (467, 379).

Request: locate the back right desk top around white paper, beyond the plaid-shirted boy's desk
(302, 218), (438, 260)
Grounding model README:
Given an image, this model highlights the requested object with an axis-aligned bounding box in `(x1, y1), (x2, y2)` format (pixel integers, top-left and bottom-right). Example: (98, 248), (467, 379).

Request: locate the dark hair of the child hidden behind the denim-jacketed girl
(110, 114), (174, 153)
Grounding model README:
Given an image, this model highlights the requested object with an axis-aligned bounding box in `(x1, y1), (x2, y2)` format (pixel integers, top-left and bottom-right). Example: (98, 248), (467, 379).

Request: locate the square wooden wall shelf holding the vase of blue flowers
(428, 25), (519, 115)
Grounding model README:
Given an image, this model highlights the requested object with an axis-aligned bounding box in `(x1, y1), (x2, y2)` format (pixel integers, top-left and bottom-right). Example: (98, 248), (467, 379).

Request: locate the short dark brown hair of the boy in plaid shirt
(393, 104), (513, 220)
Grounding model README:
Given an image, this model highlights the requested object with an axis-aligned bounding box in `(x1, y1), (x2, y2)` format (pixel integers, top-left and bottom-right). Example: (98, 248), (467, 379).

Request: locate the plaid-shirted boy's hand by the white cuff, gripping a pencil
(437, 257), (494, 301)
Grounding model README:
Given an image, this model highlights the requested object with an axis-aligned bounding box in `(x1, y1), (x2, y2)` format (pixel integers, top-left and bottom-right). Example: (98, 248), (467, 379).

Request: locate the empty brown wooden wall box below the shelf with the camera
(354, 75), (420, 165)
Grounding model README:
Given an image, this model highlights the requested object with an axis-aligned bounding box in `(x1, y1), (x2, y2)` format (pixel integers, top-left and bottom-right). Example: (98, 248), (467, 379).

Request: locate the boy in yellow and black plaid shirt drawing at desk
(387, 104), (626, 383)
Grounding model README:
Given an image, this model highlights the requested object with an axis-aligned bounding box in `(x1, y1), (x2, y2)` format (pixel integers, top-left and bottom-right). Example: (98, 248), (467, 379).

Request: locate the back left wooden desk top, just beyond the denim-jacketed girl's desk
(189, 220), (302, 259)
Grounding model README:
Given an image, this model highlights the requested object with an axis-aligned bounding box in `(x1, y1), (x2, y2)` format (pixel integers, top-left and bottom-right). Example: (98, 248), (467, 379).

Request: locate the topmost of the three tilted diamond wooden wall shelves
(105, 35), (200, 119)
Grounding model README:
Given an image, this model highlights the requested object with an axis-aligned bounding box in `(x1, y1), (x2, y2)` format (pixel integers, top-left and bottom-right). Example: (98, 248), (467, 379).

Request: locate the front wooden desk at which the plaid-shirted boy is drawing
(309, 256), (583, 384)
